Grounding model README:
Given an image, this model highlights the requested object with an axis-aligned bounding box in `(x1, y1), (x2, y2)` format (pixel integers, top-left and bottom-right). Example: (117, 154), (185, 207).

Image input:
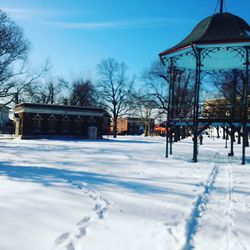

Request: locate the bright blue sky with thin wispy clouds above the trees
(0, 0), (250, 78)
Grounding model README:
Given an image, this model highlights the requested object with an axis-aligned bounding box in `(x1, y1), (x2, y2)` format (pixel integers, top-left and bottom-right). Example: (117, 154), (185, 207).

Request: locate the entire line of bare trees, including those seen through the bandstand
(0, 10), (244, 137)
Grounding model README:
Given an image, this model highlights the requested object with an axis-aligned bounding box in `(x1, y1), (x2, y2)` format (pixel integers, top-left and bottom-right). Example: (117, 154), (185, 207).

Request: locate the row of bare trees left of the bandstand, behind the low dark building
(0, 10), (174, 136)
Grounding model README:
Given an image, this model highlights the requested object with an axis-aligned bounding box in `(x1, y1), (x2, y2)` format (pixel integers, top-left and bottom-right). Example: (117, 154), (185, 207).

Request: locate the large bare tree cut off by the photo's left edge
(0, 10), (30, 104)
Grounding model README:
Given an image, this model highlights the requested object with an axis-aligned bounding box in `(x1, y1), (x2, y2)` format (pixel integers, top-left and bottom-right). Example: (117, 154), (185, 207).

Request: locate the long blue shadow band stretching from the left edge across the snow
(0, 162), (190, 197)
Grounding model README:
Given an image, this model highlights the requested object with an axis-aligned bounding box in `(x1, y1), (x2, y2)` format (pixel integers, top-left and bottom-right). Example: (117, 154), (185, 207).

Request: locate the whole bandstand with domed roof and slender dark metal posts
(160, 0), (250, 164)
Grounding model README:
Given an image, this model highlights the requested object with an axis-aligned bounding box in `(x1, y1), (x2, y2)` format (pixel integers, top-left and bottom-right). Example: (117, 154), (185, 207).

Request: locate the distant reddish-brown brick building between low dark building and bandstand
(117, 117), (154, 135)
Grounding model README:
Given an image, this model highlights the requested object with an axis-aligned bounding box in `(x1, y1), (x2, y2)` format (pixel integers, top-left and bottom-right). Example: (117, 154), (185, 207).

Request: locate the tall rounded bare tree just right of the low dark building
(97, 58), (133, 138)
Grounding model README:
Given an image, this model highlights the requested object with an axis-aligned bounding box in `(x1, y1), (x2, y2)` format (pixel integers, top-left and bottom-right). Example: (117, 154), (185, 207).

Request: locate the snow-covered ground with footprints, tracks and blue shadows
(0, 137), (250, 250)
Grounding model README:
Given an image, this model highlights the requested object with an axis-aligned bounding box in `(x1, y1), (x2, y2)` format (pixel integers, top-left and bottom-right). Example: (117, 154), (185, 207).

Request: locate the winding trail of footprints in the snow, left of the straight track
(54, 183), (112, 250)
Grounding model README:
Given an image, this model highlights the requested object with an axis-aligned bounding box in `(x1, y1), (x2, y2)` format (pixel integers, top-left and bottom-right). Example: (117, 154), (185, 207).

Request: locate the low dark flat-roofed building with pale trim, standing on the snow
(14, 103), (109, 140)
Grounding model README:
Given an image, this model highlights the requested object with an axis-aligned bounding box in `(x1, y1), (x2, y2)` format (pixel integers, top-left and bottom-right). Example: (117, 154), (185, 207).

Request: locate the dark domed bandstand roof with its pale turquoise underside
(160, 13), (250, 70)
